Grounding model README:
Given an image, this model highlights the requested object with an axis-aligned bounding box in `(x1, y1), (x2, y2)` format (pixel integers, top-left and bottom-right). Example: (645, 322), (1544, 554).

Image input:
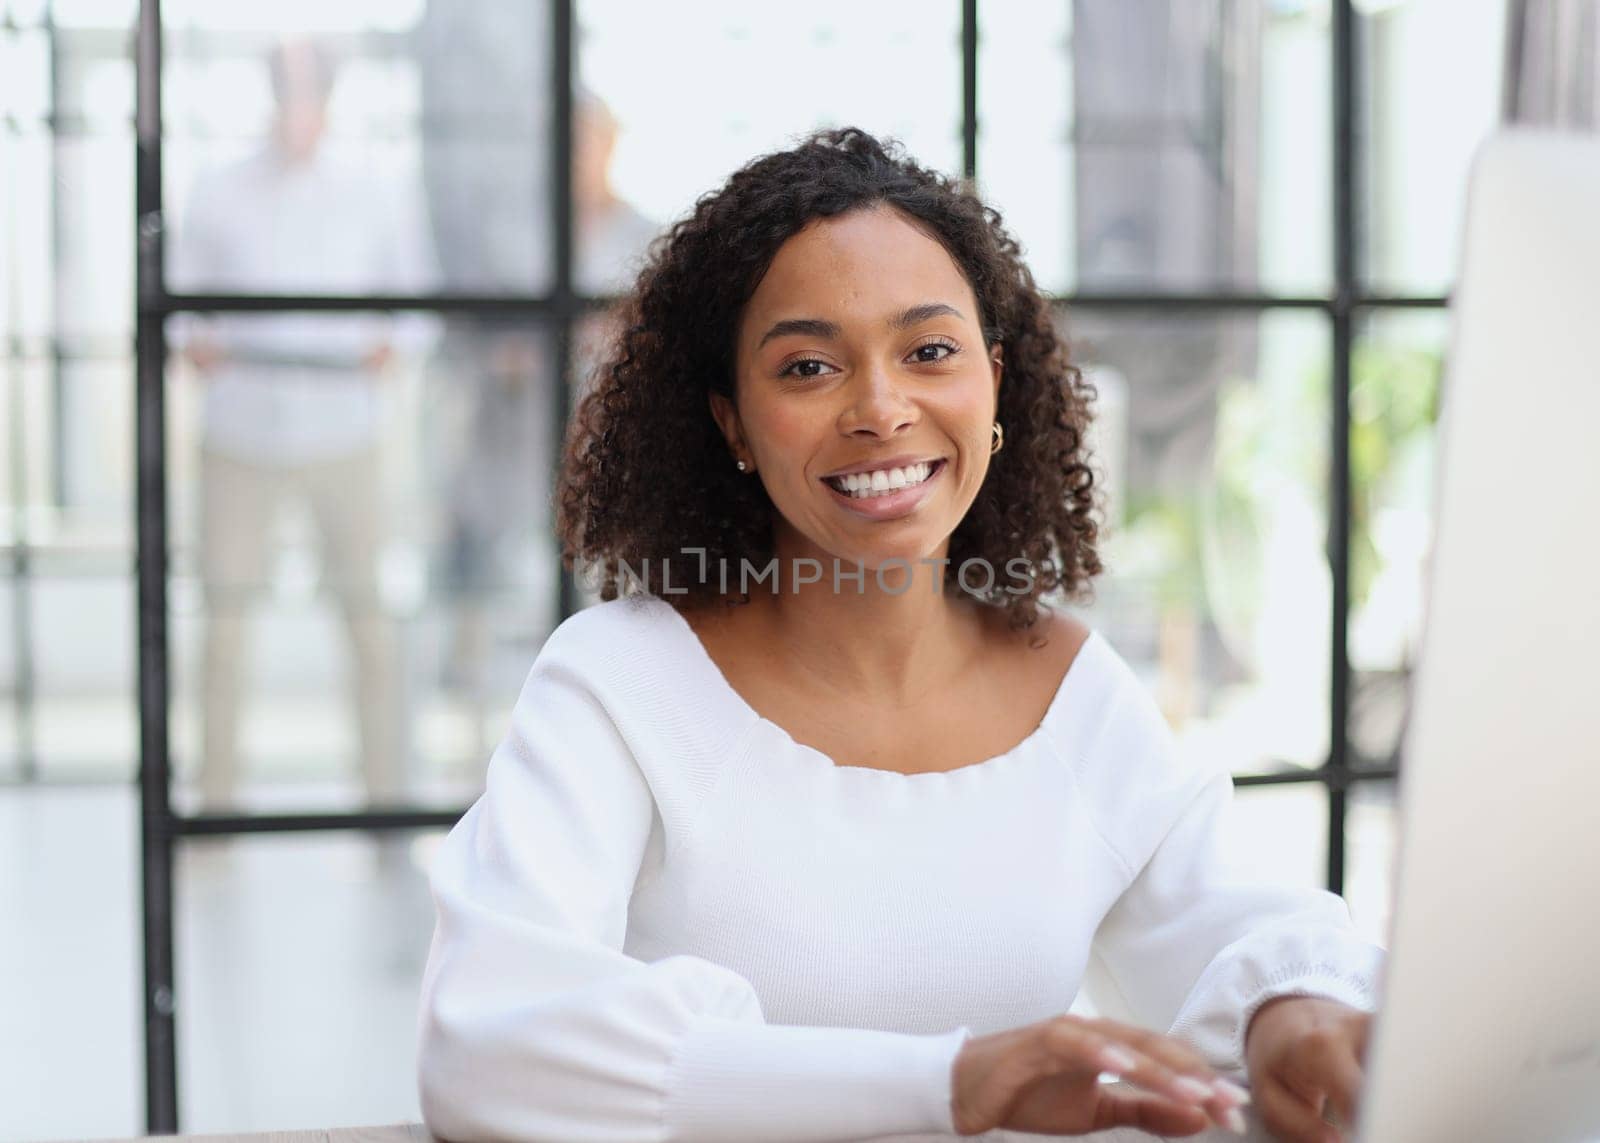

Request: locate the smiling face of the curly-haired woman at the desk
(712, 207), (1002, 578)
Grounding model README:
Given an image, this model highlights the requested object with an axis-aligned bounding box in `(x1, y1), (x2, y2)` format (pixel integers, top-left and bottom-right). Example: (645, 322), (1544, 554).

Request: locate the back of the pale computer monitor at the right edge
(1352, 130), (1600, 1143)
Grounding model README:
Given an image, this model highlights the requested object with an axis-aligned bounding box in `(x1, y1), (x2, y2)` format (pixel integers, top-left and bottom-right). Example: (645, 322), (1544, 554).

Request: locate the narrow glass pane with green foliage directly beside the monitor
(1349, 311), (1450, 765)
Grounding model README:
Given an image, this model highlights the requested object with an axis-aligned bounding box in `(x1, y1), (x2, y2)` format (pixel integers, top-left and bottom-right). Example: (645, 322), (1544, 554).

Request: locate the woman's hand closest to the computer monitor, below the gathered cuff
(1245, 996), (1373, 1143)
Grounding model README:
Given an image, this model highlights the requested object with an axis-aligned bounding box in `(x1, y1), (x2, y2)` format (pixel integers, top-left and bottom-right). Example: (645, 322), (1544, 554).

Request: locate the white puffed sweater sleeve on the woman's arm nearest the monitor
(1077, 649), (1384, 1079)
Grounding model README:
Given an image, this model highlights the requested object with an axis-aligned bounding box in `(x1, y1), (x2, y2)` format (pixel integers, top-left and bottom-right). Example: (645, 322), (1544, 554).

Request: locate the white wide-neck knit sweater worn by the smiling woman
(418, 596), (1382, 1143)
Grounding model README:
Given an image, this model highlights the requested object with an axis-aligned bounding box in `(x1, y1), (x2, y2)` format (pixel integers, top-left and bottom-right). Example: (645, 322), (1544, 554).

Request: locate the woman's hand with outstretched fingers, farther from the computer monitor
(950, 1013), (1250, 1135)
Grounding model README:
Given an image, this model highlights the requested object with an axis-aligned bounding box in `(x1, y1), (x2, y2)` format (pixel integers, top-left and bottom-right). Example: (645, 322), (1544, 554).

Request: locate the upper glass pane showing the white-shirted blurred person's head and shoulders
(163, 0), (550, 295)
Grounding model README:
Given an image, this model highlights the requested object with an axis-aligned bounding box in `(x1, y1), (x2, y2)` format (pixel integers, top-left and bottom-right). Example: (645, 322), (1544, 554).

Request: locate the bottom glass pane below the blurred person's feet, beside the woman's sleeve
(176, 831), (442, 1133)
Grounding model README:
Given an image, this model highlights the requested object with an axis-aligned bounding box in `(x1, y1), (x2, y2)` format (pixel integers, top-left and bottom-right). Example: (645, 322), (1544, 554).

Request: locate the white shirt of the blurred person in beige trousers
(168, 144), (438, 466)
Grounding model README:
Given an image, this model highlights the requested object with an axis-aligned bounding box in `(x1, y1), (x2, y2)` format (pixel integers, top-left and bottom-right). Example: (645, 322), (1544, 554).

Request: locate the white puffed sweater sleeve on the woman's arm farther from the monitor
(418, 629), (968, 1143)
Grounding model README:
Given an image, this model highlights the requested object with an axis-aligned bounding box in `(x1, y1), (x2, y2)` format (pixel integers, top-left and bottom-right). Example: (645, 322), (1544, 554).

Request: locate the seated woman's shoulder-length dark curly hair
(555, 126), (1102, 629)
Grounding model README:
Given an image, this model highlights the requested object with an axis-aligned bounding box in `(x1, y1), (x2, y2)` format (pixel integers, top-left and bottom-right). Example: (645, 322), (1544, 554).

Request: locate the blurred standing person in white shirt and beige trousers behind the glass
(171, 40), (434, 810)
